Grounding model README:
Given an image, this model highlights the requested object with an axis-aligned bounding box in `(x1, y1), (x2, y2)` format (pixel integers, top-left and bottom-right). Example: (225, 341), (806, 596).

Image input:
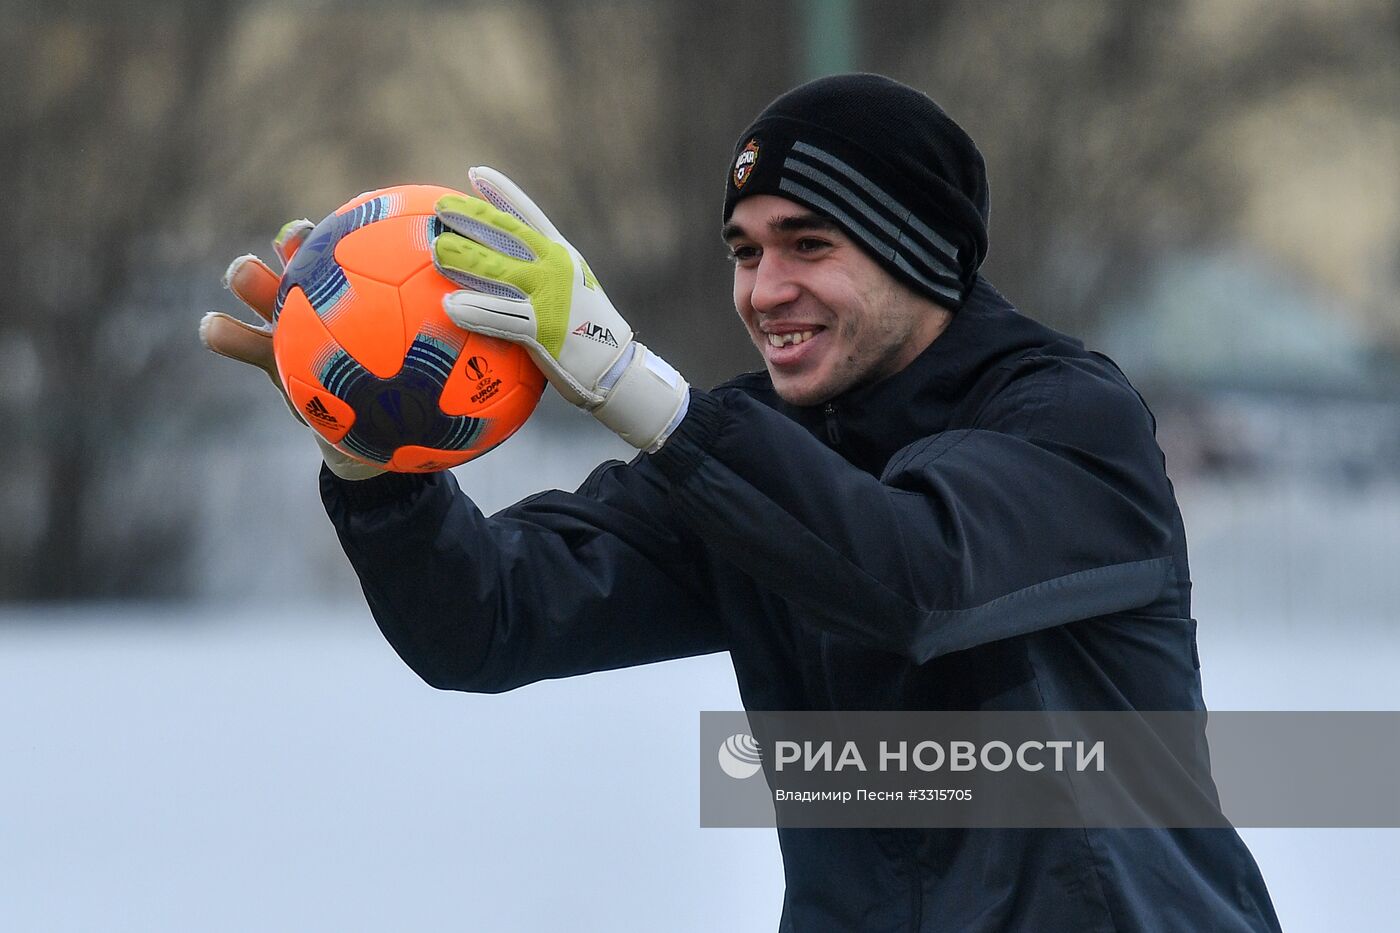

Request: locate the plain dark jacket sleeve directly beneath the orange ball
(321, 451), (725, 693)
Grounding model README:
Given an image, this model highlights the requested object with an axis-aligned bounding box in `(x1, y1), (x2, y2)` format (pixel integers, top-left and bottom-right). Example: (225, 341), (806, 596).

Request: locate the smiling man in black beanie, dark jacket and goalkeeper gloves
(203, 74), (1278, 933)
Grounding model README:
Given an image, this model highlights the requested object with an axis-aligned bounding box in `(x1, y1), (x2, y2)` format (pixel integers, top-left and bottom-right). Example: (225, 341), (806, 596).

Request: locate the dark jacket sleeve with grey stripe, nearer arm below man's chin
(652, 360), (1175, 663)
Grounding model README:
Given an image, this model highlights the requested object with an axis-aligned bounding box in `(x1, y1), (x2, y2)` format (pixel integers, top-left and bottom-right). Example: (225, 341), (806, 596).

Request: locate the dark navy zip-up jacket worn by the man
(322, 282), (1278, 933)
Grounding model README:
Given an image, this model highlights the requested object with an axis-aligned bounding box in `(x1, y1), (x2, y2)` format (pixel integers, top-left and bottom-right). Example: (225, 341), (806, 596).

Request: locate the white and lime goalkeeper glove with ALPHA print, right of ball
(434, 167), (689, 451)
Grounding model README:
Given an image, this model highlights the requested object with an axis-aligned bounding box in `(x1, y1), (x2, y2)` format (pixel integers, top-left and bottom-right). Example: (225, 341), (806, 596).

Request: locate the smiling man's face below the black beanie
(722, 195), (951, 405)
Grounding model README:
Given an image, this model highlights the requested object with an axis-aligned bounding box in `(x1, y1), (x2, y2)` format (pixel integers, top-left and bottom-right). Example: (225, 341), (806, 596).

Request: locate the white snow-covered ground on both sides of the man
(0, 476), (1400, 933)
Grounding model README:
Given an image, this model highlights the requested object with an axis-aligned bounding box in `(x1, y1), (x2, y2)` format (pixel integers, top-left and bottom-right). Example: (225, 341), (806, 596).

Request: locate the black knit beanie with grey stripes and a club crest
(724, 74), (990, 308)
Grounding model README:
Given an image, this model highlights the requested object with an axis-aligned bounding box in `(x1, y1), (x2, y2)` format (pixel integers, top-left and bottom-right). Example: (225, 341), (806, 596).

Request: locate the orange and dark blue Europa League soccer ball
(273, 185), (545, 474)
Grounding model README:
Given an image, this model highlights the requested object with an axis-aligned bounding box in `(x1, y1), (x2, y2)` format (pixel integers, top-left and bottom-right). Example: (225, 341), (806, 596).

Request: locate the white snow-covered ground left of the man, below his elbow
(0, 609), (781, 932)
